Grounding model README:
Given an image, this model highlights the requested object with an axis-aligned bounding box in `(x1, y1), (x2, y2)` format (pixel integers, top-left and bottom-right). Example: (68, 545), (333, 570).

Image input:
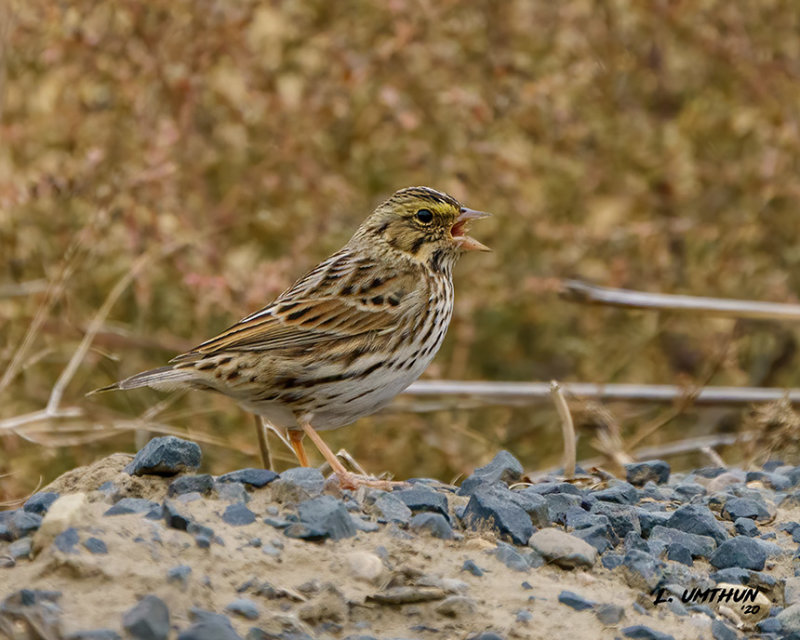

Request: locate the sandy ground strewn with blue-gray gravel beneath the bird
(0, 436), (800, 640)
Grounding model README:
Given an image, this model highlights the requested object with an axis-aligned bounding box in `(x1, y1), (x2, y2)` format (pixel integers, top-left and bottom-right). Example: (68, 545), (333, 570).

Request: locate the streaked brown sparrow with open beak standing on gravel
(92, 186), (490, 488)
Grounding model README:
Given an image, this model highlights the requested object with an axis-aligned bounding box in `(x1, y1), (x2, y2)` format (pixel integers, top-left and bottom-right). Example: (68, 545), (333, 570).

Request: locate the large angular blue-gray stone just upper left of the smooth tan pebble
(464, 485), (533, 545)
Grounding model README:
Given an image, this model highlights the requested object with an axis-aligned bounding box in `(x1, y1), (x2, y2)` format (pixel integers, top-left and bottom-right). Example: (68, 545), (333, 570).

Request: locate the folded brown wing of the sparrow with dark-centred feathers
(172, 261), (419, 363)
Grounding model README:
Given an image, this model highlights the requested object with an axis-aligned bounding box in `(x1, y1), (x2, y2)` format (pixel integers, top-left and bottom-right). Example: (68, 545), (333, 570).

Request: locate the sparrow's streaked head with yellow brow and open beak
(356, 187), (491, 267)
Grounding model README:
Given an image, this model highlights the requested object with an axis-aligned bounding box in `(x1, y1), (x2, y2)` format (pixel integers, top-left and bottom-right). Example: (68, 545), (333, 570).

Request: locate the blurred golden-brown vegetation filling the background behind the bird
(0, 0), (800, 500)
